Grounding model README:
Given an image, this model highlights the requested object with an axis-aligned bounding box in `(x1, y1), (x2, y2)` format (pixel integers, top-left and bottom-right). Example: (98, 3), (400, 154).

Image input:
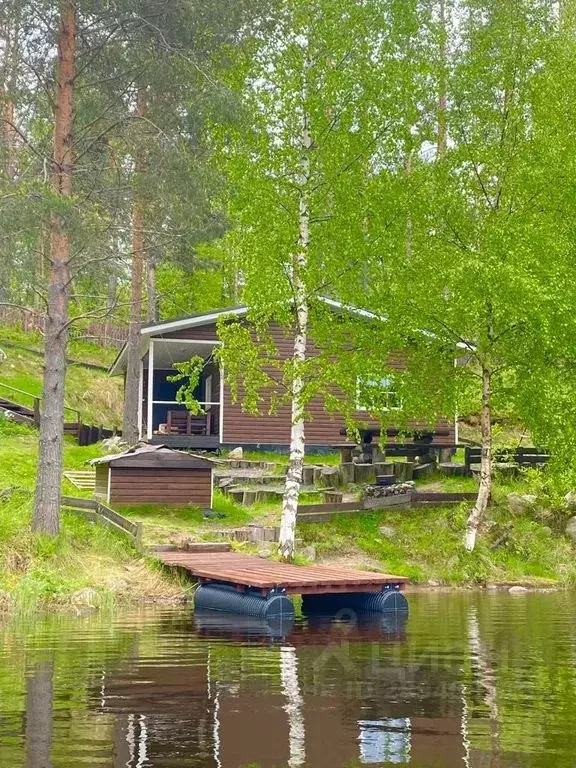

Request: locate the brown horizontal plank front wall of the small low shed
(110, 466), (212, 507)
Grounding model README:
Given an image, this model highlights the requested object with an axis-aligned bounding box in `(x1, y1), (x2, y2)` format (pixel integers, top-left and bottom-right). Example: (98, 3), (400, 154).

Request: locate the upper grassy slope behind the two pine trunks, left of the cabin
(0, 328), (122, 427)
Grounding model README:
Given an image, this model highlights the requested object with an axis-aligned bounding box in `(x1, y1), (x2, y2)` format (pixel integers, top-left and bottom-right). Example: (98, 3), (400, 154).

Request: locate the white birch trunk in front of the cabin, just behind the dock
(278, 105), (312, 560)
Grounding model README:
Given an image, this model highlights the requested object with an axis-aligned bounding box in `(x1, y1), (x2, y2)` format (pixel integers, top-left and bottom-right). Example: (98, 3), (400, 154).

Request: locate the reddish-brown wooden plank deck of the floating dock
(158, 552), (408, 595)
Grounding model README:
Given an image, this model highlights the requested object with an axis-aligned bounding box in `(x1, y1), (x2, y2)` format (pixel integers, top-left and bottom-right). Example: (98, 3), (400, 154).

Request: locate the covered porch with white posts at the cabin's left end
(138, 337), (223, 449)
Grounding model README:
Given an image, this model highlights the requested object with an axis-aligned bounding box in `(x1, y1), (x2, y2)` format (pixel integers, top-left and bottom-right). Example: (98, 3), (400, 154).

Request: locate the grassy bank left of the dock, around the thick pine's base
(0, 419), (183, 610)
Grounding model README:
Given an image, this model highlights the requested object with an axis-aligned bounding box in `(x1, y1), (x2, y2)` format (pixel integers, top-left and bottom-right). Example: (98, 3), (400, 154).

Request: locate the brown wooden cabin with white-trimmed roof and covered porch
(110, 299), (457, 451)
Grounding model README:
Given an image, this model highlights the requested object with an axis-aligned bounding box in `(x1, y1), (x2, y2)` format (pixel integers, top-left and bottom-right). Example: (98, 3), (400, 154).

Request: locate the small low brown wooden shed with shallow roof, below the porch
(91, 445), (213, 508)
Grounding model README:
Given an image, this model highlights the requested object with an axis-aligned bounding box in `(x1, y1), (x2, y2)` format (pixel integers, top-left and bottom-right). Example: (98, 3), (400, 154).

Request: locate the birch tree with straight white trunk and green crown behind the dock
(214, 0), (426, 560)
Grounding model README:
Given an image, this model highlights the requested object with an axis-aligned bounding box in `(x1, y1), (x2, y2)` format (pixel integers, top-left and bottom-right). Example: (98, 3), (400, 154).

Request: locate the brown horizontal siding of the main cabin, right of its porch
(155, 323), (455, 446)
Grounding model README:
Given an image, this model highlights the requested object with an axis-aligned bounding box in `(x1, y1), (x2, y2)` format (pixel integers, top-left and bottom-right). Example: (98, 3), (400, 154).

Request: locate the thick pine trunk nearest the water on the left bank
(32, 0), (77, 536)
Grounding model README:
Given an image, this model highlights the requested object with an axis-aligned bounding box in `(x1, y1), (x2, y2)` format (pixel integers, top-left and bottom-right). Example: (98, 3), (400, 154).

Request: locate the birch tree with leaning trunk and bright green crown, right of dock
(360, 0), (571, 550)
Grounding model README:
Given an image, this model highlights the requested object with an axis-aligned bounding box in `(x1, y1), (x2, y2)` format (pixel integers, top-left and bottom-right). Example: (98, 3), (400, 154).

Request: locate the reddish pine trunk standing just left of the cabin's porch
(122, 88), (146, 445)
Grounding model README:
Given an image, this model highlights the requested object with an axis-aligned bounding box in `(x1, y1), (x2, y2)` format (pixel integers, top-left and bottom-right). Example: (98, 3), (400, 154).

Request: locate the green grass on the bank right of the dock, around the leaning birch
(299, 496), (576, 585)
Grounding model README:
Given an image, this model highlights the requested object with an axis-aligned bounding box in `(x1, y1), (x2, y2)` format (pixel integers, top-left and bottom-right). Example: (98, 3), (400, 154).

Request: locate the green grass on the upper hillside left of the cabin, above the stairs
(0, 329), (123, 427)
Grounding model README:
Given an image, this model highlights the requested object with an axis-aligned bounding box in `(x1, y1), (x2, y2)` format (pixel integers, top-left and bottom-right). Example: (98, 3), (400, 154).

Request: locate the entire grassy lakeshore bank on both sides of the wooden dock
(0, 422), (576, 604)
